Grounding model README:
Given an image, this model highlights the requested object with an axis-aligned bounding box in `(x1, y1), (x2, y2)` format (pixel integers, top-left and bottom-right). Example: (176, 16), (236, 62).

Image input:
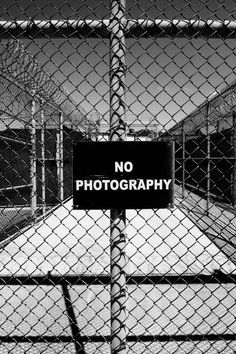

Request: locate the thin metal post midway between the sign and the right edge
(206, 102), (211, 214)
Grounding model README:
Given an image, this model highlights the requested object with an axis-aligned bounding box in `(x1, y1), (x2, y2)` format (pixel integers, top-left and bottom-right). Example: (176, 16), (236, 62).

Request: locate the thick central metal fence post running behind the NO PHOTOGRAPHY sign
(110, 0), (126, 354)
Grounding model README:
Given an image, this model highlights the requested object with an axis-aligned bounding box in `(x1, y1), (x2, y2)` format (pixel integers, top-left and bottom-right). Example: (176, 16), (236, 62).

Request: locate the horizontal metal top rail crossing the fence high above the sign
(0, 18), (236, 39)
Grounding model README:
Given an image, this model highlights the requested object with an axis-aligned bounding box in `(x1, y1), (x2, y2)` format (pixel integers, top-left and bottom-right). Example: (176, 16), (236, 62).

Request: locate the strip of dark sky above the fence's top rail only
(0, 0), (235, 20)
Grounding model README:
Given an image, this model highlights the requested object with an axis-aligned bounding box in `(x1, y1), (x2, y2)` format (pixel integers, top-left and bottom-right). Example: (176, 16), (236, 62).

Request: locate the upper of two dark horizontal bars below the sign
(0, 272), (236, 286)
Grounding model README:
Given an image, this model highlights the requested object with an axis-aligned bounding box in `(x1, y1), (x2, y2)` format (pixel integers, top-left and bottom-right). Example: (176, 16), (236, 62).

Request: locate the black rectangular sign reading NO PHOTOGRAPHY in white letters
(73, 142), (174, 209)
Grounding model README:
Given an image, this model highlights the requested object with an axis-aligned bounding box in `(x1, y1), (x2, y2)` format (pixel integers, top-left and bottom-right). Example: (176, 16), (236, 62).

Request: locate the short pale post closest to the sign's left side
(56, 112), (64, 202)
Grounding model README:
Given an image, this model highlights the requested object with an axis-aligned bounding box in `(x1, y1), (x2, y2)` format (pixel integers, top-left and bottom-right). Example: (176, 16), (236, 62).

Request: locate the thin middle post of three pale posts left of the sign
(40, 102), (46, 214)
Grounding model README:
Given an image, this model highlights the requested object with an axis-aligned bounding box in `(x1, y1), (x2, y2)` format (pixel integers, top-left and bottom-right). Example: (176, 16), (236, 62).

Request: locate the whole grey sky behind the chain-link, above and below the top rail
(0, 0), (236, 129)
